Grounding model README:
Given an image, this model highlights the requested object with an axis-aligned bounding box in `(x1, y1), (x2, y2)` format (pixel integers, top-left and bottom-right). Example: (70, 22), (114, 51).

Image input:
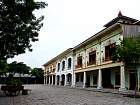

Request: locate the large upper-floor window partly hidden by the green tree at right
(104, 43), (115, 61)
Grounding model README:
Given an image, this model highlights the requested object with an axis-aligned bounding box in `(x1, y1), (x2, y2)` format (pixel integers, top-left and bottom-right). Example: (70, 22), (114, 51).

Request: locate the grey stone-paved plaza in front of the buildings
(0, 85), (140, 105)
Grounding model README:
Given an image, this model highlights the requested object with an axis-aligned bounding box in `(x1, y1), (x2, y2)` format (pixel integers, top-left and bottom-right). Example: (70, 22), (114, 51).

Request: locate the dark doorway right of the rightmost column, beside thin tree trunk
(129, 72), (136, 90)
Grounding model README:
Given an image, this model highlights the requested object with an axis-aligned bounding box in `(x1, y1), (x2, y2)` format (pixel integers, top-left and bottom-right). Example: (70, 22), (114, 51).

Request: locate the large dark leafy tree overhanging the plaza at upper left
(0, 0), (47, 62)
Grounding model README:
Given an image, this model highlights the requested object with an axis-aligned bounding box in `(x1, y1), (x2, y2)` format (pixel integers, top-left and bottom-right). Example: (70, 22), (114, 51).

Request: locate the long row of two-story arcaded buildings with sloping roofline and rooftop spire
(44, 12), (140, 91)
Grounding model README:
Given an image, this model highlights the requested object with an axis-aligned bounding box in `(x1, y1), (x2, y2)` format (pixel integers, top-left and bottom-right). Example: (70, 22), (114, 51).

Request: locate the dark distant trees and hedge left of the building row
(0, 61), (44, 85)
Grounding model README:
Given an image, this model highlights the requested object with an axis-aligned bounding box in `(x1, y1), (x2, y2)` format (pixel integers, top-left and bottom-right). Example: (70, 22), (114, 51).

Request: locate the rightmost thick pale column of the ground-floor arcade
(119, 65), (126, 91)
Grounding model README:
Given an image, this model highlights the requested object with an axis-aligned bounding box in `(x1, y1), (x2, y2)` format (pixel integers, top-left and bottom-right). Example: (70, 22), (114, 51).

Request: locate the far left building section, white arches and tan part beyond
(43, 48), (73, 86)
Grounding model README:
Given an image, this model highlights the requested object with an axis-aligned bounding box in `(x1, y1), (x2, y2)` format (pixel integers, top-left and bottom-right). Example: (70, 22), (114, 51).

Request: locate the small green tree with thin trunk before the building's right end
(111, 34), (140, 96)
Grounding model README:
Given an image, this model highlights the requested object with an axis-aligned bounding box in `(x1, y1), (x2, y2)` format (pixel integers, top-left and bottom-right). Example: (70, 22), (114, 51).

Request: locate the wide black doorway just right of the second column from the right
(102, 69), (113, 88)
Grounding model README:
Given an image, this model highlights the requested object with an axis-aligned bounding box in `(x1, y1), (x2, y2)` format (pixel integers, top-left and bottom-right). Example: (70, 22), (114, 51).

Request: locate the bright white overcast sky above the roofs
(8, 0), (140, 68)
